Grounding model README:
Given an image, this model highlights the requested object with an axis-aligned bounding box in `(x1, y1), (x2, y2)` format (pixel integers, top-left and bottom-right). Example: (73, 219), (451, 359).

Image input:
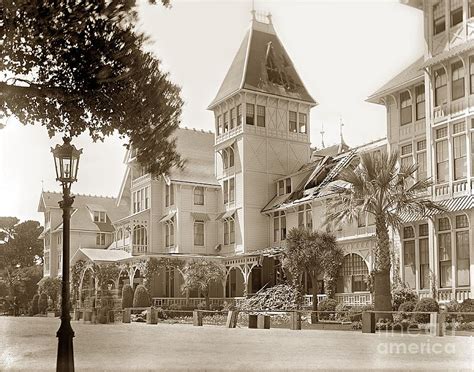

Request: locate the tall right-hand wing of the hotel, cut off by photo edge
(368, 0), (474, 301)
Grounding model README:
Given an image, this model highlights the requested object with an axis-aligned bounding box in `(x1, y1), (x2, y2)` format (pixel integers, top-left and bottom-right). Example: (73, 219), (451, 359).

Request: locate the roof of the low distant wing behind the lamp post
(38, 191), (129, 232)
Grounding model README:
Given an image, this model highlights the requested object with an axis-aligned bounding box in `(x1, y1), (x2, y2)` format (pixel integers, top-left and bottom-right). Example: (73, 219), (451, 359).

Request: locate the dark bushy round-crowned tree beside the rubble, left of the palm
(283, 228), (344, 318)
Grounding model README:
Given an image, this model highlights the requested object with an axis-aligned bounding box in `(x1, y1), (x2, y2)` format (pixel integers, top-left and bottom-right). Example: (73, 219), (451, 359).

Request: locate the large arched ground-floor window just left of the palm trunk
(337, 253), (369, 293)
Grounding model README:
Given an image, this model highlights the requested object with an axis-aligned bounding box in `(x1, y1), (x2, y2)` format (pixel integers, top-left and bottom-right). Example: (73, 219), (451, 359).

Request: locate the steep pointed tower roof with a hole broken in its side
(208, 15), (317, 109)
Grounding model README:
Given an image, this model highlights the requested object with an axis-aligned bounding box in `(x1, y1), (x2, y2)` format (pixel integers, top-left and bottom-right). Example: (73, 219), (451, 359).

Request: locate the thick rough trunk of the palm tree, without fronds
(374, 214), (392, 318)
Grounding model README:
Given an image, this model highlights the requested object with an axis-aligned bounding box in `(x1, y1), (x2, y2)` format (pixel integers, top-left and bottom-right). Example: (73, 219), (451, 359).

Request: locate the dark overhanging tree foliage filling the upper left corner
(0, 0), (182, 174)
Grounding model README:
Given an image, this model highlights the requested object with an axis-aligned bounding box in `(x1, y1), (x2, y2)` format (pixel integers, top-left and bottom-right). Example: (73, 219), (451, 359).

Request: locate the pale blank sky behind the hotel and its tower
(0, 0), (423, 222)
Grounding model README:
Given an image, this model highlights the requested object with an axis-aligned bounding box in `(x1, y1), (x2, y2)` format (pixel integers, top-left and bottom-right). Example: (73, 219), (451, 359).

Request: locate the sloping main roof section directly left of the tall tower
(169, 128), (219, 186)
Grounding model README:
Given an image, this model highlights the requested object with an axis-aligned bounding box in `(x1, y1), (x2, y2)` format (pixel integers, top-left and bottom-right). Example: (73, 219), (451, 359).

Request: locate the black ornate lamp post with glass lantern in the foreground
(51, 137), (82, 372)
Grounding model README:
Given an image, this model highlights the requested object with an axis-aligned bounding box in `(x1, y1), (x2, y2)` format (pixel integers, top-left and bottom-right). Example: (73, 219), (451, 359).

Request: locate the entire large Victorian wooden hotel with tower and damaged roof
(40, 5), (474, 305)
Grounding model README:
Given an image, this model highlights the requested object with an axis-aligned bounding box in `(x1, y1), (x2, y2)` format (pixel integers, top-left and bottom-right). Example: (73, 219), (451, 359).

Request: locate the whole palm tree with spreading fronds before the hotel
(326, 151), (443, 311)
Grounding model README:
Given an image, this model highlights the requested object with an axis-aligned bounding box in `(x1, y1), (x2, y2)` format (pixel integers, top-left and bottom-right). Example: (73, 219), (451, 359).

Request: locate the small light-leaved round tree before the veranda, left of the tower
(182, 260), (227, 308)
